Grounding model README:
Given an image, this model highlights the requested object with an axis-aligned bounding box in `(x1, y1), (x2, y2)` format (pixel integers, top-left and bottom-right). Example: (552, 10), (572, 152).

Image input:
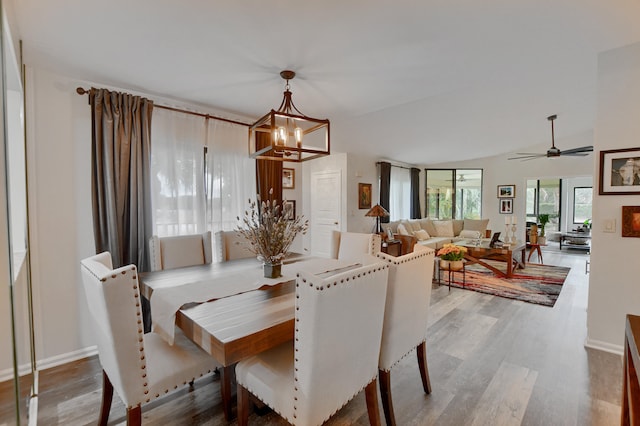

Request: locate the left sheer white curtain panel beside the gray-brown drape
(151, 108), (208, 237)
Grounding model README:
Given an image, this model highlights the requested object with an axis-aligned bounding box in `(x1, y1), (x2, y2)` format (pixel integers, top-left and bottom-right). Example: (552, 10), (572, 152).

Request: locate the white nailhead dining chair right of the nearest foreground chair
(377, 244), (435, 425)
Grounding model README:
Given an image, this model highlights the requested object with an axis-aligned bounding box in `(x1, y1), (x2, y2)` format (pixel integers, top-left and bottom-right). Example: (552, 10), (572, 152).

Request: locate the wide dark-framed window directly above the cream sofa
(425, 169), (482, 219)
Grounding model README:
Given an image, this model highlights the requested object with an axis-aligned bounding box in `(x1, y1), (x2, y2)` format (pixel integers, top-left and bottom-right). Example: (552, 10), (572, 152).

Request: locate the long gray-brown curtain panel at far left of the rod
(89, 88), (153, 271)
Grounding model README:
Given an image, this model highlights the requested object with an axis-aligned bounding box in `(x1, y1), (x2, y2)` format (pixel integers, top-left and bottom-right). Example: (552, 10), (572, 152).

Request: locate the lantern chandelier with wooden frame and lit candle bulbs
(249, 70), (331, 163)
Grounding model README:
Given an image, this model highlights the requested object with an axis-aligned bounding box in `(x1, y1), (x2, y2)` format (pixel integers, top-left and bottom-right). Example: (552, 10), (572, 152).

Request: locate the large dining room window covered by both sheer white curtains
(151, 109), (256, 253)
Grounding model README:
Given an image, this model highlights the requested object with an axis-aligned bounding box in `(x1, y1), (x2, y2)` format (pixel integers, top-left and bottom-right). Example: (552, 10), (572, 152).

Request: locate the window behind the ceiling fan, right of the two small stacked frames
(526, 179), (562, 231)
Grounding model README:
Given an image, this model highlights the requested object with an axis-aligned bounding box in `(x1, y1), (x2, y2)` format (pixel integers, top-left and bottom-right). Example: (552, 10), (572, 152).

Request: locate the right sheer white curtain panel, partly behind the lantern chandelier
(207, 120), (256, 232)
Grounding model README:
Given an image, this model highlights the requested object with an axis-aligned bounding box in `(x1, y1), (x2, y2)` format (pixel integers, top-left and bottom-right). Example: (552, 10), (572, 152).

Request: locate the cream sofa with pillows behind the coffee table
(382, 219), (491, 250)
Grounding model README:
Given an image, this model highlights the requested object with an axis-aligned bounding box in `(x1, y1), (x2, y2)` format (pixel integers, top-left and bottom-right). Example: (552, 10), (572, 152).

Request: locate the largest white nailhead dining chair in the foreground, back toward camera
(236, 262), (388, 425)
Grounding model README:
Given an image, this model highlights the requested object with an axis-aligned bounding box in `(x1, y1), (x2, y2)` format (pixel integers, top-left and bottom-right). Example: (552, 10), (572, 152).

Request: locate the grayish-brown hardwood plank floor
(0, 250), (624, 426)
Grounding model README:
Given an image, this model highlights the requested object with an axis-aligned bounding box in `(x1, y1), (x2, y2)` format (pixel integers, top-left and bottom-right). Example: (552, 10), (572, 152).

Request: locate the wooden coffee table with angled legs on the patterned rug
(454, 240), (527, 278)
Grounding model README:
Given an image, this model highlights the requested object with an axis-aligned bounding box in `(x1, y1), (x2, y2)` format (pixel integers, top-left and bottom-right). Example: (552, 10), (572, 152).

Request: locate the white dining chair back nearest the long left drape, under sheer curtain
(149, 231), (212, 271)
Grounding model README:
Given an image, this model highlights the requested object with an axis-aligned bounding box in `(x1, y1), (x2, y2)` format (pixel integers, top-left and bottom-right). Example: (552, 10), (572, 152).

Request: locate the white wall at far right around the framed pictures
(587, 43), (640, 352)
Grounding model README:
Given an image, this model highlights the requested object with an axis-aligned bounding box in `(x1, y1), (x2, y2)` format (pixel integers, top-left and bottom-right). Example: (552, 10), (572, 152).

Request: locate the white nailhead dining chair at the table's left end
(81, 252), (217, 425)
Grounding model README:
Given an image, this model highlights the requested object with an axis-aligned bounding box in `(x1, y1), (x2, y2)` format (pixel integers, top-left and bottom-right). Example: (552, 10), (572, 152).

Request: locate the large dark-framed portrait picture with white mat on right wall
(599, 148), (640, 195)
